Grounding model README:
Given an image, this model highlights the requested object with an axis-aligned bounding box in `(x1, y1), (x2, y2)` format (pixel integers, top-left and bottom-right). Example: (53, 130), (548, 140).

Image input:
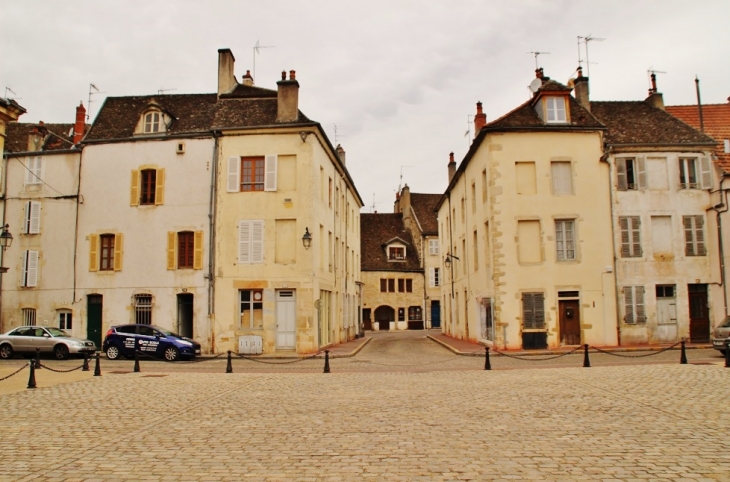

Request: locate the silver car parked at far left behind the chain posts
(0, 326), (96, 360)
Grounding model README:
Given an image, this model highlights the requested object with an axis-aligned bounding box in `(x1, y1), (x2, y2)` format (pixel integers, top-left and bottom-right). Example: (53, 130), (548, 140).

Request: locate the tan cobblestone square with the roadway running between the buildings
(0, 334), (730, 482)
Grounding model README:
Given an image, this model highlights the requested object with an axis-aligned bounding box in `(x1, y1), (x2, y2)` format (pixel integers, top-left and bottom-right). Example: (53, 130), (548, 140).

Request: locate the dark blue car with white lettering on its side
(102, 325), (200, 361)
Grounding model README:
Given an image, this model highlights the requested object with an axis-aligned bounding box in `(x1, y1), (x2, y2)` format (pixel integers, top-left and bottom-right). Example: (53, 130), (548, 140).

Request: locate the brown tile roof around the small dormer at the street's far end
(360, 213), (423, 271)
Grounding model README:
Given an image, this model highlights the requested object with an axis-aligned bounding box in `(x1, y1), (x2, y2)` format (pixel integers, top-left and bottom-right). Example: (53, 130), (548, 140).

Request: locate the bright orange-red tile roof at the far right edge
(666, 99), (730, 173)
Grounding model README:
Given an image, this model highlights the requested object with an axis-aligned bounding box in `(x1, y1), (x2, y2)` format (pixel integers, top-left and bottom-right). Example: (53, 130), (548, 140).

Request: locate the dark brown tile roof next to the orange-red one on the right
(591, 101), (713, 146)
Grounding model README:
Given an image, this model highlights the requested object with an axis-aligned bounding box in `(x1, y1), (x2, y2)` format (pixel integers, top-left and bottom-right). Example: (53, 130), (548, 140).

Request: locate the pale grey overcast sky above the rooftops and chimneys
(0, 0), (730, 212)
